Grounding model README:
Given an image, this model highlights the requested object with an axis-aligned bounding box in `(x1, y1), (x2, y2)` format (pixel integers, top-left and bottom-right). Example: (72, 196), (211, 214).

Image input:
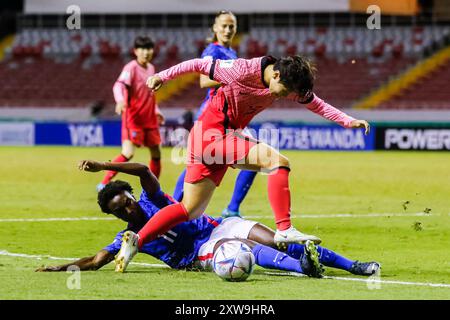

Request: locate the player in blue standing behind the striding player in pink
(173, 11), (256, 218)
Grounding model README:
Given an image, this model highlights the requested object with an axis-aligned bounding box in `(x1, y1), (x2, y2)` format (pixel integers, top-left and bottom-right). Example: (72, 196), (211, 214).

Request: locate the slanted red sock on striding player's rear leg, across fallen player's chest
(138, 202), (189, 248)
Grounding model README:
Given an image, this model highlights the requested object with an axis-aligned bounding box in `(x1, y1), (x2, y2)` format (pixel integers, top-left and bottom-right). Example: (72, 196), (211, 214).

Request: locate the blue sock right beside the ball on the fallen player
(252, 244), (303, 273)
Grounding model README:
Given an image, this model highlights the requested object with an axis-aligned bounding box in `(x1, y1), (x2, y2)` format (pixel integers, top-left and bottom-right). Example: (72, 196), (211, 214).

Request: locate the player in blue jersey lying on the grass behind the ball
(36, 160), (380, 278)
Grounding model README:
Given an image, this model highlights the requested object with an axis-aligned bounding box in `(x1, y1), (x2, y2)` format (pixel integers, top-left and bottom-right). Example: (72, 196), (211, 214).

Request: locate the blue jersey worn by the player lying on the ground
(103, 190), (222, 269)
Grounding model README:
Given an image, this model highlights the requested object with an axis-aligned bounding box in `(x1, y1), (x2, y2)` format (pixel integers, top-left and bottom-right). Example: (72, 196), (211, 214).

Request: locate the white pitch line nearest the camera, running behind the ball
(0, 250), (450, 288)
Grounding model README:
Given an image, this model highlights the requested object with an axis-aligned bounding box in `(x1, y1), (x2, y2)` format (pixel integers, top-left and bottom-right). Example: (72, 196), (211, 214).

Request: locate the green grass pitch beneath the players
(0, 147), (450, 300)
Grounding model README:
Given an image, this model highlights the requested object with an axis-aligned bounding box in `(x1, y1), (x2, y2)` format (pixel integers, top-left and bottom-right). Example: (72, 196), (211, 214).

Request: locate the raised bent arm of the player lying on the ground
(78, 160), (160, 196)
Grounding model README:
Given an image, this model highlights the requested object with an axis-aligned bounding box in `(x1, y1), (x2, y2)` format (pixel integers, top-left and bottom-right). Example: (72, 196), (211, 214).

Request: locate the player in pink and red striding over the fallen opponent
(116, 56), (369, 268)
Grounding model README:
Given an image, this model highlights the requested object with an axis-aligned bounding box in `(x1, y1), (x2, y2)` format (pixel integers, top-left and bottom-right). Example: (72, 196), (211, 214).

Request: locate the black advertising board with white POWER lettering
(376, 124), (450, 151)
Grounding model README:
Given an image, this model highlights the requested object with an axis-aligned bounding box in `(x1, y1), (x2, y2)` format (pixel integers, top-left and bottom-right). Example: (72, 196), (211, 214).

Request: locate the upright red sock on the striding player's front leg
(268, 167), (291, 230)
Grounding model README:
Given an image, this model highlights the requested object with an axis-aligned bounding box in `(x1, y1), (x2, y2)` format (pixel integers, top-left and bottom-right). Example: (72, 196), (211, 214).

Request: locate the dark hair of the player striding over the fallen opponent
(273, 55), (317, 98)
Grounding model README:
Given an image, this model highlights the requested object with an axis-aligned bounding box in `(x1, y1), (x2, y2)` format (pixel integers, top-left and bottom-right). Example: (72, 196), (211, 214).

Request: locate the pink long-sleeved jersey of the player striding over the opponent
(157, 57), (355, 129)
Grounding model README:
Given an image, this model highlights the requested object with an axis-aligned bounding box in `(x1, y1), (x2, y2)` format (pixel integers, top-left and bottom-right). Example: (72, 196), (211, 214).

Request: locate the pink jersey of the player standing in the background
(113, 60), (158, 129)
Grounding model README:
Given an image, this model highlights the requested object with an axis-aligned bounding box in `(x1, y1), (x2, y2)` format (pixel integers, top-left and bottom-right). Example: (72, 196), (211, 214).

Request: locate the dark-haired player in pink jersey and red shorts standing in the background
(97, 36), (164, 191)
